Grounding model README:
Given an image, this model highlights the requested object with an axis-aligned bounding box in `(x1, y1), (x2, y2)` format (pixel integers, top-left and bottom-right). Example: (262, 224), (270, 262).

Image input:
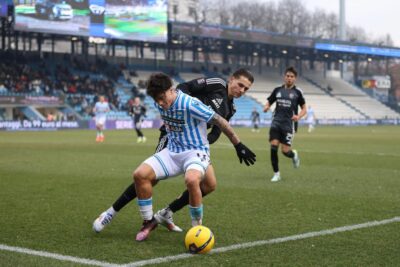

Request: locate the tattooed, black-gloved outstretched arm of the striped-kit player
(209, 113), (256, 166)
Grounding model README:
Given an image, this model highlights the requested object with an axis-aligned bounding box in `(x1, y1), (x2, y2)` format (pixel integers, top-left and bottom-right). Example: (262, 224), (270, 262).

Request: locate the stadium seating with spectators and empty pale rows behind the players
(0, 52), (400, 120)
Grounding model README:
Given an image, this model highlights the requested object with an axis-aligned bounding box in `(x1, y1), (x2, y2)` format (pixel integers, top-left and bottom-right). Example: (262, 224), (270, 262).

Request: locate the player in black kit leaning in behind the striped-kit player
(93, 68), (254, 239)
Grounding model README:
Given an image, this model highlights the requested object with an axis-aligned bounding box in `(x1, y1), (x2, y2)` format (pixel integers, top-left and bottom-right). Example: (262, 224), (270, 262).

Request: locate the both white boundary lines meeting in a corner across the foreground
(0, 217), (400, 267)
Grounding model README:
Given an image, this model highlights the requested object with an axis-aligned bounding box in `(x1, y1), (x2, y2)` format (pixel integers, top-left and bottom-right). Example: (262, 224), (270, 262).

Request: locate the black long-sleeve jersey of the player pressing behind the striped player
(177, 77), (236, 144)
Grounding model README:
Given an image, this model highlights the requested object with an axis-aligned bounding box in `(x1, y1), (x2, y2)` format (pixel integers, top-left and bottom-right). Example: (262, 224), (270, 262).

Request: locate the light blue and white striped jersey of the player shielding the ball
(155, 90), (215, 154)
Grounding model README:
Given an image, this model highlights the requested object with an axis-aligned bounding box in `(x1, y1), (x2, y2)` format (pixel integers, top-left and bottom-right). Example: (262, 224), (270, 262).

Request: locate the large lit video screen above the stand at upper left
(14, 0), (168, 42)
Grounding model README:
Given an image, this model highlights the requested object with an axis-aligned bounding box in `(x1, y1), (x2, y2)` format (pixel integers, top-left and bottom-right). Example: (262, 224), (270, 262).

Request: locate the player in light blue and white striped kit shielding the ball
(133, 73), (255, 241)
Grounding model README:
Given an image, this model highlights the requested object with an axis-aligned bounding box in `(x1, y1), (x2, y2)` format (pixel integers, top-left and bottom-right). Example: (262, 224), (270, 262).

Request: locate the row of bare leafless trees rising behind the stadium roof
(195, 0), (393, 45)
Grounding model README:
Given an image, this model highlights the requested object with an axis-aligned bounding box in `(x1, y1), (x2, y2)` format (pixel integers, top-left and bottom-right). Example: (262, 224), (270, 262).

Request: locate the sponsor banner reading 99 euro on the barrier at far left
(0, 120), (84, 131)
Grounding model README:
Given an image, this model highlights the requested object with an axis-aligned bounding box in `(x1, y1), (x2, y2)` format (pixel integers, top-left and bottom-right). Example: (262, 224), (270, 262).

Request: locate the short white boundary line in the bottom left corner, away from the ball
(0, 244), (120, 267)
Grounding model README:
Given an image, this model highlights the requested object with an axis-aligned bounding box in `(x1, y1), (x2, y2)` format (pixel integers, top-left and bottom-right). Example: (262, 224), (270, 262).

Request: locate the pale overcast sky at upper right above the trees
(261, 0), (400, 47)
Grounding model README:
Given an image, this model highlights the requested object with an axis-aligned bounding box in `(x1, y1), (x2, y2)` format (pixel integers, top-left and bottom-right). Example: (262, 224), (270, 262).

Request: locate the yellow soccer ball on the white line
(185, 225), (215, 254)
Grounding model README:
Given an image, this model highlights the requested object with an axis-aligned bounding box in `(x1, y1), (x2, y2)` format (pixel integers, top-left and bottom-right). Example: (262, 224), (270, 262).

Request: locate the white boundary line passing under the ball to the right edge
(123, 217), (400, 267)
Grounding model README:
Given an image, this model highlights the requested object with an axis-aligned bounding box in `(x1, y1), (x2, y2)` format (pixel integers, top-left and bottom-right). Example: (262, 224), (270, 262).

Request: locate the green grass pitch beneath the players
(0, 126), (400, 266)
